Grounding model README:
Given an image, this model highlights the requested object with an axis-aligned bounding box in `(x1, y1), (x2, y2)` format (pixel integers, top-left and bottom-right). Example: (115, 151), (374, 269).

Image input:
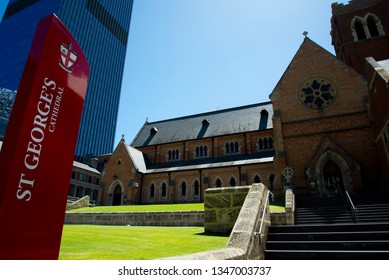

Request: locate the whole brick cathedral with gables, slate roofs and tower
(87, 0), (389, 205)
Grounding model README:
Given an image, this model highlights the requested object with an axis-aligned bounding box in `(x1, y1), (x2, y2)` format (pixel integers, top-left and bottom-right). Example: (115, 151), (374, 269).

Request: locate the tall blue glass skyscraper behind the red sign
(0, 0), (133, 161)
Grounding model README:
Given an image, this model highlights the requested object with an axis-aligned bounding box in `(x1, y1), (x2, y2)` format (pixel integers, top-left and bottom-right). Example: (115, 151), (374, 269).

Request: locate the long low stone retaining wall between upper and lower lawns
(65, 210), (204, 226)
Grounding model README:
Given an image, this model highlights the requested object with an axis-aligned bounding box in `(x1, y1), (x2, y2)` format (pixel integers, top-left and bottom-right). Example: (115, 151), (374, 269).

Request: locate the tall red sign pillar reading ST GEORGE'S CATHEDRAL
(0, 15), (89, 260)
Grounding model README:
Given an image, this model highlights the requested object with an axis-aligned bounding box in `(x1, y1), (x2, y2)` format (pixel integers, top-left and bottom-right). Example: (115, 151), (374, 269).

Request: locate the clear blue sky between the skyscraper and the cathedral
(115, 0), (348, 145)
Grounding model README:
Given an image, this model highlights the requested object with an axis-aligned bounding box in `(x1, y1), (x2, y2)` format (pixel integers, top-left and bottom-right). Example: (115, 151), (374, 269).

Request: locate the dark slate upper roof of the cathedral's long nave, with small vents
(131, 102), (273, 147)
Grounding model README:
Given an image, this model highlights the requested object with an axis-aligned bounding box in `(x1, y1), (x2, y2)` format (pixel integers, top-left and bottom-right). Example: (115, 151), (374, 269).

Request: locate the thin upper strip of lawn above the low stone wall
(69, 201), (285, 213)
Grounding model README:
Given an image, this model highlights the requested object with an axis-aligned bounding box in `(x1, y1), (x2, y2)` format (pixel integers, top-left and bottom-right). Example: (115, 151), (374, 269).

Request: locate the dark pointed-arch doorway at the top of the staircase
(323, 159), (344, 196)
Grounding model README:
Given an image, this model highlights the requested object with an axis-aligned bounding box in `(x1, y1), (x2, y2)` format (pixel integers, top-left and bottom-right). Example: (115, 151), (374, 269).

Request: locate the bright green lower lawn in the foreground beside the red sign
(59, 225), (228, 260)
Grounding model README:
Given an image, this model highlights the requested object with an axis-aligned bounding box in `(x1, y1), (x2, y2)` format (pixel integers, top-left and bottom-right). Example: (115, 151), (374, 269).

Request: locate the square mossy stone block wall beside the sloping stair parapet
(204, 186), (250, 234)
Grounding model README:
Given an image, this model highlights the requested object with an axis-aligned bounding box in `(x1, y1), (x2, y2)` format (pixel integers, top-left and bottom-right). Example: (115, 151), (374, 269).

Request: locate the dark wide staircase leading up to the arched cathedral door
(265, 194), (389, 260)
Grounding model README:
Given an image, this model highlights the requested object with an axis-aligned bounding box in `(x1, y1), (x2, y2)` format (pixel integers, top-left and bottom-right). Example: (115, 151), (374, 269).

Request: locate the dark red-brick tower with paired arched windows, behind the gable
(331, 0), (389, 75)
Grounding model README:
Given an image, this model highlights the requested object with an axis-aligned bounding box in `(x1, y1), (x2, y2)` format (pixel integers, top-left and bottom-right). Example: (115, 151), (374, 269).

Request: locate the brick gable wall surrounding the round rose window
(271, 39), (377, 195)
